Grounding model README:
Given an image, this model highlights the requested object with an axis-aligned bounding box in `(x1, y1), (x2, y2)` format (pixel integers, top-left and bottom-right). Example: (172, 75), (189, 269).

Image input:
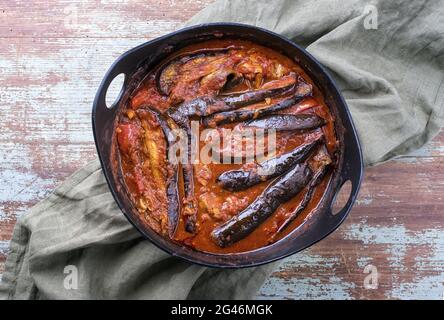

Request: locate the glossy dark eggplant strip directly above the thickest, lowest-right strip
(216, 138), (322, 191)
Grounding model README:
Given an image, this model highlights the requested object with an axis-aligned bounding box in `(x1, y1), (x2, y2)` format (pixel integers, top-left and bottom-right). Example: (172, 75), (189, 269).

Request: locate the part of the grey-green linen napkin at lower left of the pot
(0, 160), (273, 299)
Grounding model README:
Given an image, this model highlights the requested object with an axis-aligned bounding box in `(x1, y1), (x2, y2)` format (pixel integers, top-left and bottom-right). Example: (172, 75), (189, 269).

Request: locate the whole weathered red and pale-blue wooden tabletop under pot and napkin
(0, 0), (444, 299)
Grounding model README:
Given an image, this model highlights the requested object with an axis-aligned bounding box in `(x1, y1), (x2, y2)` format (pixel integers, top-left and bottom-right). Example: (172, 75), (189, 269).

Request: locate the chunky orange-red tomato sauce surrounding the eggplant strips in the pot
(115, 39), (338, 253)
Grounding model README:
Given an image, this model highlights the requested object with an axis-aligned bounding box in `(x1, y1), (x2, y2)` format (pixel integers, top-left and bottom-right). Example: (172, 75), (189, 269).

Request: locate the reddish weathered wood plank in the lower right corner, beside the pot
(259, 155), (444, 299)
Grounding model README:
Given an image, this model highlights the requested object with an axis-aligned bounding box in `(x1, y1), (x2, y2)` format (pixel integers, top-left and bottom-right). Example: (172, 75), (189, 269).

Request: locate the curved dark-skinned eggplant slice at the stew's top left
(155, 48), (234, 96)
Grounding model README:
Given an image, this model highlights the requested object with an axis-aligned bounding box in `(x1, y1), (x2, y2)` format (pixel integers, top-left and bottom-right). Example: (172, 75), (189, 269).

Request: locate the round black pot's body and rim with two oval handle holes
(92, 23), (363, 268)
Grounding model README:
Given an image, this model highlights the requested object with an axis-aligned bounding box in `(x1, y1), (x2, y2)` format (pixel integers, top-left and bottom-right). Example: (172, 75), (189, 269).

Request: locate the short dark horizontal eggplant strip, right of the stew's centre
(244, 113), (325, 131)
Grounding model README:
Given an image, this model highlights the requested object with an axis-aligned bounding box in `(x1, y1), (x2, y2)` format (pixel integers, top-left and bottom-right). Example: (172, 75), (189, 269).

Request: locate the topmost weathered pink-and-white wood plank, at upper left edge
(0, 0), (214, 39)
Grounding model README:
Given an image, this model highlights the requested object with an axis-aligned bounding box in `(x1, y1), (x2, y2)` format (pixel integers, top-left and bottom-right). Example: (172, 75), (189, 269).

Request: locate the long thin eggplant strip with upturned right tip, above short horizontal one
(202, 81), (312, 128)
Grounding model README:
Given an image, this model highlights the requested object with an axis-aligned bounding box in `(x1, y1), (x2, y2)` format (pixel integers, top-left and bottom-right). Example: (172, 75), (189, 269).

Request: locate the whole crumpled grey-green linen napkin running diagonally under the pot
(0, 0), (444, 299)
